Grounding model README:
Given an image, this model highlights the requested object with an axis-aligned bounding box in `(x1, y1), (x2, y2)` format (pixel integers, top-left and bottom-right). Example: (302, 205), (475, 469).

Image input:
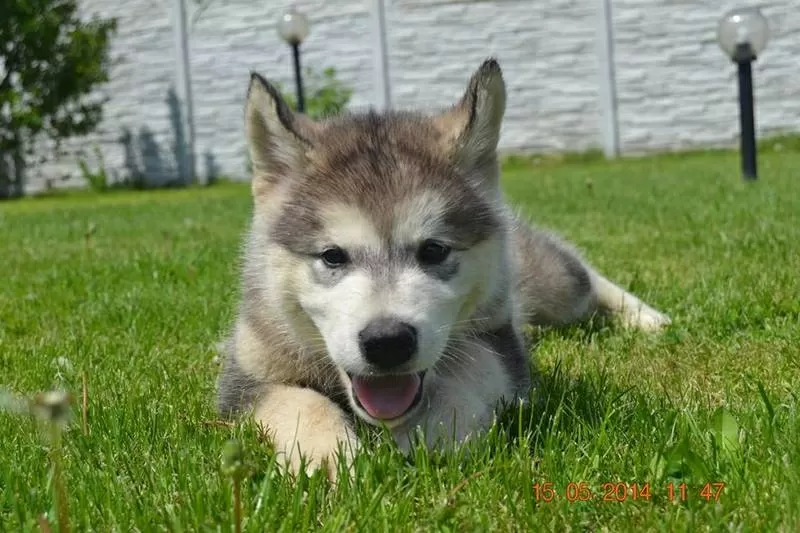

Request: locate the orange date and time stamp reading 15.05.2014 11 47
(533, 481), (725, 503)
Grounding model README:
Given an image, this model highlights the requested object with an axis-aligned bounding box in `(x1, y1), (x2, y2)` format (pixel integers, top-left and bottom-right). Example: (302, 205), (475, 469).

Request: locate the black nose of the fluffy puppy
(358, 318), (417, 369)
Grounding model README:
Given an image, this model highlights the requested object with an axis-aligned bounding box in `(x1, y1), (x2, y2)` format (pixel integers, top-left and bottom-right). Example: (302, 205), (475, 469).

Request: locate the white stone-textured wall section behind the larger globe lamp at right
(613, 0), (800, 153)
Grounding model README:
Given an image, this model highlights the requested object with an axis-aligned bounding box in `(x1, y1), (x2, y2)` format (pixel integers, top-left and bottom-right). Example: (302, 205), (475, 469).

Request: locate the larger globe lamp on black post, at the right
(717, 8), (769, 180)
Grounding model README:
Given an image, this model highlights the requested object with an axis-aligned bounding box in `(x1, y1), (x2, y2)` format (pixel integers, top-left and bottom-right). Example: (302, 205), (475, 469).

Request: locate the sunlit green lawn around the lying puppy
(0, 150), (800, 532)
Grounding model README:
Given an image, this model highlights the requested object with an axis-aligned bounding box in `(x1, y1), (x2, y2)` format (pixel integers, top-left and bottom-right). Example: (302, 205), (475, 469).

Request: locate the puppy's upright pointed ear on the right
(434, 59), (506, 165)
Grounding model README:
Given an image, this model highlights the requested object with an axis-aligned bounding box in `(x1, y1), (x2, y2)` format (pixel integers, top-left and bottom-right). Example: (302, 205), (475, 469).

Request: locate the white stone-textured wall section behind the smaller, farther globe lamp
(191, 0), (373, 183)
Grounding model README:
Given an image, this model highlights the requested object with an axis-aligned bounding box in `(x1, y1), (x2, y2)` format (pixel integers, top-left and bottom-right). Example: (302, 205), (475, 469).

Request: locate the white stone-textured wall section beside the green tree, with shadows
(27, 0), (183, 190)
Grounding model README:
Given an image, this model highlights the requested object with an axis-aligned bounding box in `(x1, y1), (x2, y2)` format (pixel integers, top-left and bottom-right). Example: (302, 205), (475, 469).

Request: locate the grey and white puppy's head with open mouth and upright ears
(246, 60), (506, 425)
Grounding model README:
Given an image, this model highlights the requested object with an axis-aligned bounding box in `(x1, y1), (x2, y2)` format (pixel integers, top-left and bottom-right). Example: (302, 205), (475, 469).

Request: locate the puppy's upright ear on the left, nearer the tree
(245, 73), (316, 196)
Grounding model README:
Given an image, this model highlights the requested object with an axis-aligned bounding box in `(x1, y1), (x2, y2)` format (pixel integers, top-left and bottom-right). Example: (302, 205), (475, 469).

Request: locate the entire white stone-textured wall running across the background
(21, 0), (800, 190)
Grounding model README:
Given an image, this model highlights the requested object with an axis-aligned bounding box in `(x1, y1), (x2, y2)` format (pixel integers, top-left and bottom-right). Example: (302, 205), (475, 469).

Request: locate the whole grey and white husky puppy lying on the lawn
(218, 59), (669, 476)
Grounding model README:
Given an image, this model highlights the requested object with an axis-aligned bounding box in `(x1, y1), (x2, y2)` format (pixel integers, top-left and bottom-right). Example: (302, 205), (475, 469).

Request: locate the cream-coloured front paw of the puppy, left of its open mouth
(255, 385), (359, 480)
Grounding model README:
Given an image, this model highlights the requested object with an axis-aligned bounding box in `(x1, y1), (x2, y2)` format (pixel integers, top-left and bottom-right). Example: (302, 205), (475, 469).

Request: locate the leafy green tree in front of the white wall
(0, 0), (117, 198)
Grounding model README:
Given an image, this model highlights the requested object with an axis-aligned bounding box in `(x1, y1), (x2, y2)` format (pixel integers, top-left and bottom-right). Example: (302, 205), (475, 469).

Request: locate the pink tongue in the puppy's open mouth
(353, 374), (420, 420)
